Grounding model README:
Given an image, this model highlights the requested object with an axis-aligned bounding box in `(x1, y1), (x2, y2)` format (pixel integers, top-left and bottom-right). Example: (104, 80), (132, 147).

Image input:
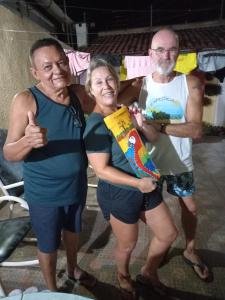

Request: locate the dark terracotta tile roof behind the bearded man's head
(82, 25), (225, 55)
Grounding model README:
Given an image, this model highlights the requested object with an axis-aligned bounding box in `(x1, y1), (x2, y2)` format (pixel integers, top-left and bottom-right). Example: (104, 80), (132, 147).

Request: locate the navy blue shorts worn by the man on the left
(28, 203), (84, 253)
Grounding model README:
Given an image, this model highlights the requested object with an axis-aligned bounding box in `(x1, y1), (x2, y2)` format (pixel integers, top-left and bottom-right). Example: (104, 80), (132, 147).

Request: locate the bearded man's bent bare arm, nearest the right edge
(156, 75), (203, 139)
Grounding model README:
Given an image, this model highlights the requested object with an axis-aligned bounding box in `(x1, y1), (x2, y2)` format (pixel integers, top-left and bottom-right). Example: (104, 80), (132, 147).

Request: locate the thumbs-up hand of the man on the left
(25, 111), (48, 148)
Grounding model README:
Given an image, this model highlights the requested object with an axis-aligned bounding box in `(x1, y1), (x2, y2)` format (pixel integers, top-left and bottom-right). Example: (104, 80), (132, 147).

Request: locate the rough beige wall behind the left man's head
(0, 5), (50, 128)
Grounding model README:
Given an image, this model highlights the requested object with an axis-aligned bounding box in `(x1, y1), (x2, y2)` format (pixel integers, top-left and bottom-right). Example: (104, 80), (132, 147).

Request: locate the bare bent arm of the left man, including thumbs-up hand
(3, 91), (47, 161)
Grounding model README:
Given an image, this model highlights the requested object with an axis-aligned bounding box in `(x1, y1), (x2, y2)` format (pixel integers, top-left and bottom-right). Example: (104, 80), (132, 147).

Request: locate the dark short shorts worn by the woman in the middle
(97, 180), (163, 224)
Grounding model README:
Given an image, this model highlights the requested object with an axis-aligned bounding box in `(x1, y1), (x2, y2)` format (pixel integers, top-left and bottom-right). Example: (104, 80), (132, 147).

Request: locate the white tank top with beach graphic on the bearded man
(139, 74), (193, 175)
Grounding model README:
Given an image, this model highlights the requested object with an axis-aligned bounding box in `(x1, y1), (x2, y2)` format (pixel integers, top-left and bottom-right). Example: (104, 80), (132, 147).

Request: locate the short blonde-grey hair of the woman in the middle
(85, 56), (120, 97)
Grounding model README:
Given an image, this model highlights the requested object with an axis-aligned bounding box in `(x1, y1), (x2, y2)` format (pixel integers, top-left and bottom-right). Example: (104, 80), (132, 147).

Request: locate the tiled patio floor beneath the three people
(0, 137), (225, 300)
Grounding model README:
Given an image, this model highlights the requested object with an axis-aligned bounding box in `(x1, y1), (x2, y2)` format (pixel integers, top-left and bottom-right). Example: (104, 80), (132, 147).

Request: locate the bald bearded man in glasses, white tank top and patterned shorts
(119, 28), (212, 281)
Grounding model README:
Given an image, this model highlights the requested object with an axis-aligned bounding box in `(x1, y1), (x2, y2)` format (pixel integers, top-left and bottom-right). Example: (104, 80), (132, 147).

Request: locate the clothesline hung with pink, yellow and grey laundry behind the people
(65, 49), (225, 84)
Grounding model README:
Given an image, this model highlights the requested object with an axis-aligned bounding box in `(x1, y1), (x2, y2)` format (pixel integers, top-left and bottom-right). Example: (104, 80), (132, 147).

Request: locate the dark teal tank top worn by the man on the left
(24, 86), (87, 206)
